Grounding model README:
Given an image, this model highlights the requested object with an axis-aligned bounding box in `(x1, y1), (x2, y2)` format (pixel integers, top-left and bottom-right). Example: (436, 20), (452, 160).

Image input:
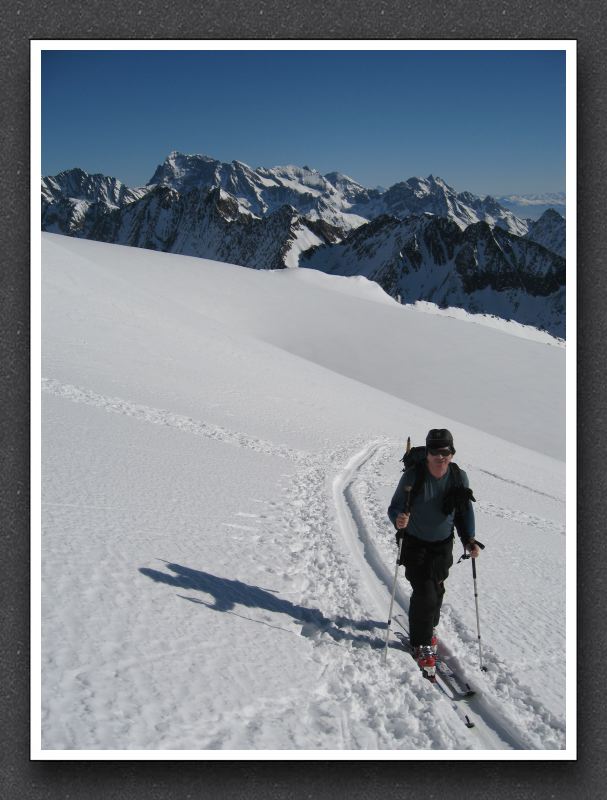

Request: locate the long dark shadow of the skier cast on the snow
(139, 561), (394, 648)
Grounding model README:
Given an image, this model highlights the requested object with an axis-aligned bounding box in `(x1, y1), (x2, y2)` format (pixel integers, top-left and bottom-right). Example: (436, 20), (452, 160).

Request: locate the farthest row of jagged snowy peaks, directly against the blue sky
(43, 151), (528, 238)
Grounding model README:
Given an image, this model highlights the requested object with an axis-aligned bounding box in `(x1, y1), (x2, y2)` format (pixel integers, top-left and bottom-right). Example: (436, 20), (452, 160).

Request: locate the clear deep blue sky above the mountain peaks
(42, 50), (565, 195)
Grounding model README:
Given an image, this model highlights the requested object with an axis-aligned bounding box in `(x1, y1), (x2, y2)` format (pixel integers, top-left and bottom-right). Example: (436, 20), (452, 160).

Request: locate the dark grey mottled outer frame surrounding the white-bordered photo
(0, 0), (607, 800)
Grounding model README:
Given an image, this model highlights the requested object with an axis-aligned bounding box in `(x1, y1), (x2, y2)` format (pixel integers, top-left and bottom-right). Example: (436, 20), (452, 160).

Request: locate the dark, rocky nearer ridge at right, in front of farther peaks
(300, 214), (565, 337)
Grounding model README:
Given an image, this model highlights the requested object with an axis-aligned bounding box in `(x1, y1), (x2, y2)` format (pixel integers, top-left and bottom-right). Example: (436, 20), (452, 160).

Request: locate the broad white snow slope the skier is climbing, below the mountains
(33, 234), (574, 758)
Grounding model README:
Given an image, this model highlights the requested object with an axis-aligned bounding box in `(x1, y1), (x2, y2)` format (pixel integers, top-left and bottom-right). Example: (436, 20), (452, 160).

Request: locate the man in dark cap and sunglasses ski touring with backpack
(388, 428), (480, 680)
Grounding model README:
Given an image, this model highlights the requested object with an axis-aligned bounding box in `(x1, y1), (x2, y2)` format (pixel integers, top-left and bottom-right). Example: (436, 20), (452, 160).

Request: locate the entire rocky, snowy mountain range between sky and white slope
(42, 152), (565, 336)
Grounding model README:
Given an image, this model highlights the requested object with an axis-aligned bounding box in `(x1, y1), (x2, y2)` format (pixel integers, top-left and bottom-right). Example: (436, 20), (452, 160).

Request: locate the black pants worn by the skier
(400, 534), (453, 647)
